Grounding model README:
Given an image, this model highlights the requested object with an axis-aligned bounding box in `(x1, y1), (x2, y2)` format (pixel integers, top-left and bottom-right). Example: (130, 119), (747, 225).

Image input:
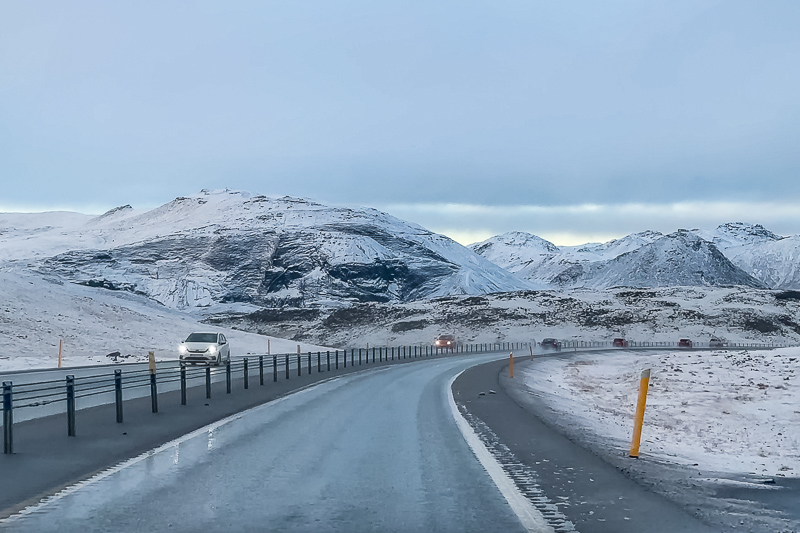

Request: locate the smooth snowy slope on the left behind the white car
(0, 269), (330, 371)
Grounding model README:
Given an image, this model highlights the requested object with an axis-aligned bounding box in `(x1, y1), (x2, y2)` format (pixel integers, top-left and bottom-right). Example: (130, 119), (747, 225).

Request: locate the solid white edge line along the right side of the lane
(447, 371), (555, 533)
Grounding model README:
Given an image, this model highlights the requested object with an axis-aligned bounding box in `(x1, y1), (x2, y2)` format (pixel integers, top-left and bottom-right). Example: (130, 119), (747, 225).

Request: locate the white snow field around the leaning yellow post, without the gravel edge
(520, 347), (800, 477)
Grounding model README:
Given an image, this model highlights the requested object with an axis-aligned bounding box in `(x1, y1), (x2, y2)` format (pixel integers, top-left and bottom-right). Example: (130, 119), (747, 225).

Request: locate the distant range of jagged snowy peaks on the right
(470, 223), (800, 289)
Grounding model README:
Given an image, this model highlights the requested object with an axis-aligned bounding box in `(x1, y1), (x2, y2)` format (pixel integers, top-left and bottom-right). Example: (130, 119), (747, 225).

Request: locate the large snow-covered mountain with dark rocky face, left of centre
(0, 190), (536, 309)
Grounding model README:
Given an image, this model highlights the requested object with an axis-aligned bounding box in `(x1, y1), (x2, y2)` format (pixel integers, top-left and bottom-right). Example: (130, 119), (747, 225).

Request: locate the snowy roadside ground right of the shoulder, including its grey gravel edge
(518, 348), (800, 531)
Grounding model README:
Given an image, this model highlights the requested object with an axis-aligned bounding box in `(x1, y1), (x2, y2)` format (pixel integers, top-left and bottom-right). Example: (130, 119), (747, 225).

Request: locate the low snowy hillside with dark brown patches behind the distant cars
(219, 287), (800, 347)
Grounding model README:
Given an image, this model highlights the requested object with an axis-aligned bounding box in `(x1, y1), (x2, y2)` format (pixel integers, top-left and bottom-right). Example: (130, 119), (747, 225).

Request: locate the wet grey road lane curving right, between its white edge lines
(0, 354), (536, 532)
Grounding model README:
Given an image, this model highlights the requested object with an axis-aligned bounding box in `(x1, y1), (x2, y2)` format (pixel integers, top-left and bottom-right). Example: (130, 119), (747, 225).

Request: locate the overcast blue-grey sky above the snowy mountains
(0, 0), (800, 244)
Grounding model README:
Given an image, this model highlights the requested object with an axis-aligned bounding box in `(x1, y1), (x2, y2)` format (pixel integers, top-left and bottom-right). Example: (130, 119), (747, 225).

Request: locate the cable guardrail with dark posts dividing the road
(3, 342), (531, 454)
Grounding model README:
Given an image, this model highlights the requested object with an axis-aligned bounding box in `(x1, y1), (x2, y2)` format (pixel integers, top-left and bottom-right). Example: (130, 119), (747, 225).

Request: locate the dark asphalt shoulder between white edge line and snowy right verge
(453, 361), (717, 533)
